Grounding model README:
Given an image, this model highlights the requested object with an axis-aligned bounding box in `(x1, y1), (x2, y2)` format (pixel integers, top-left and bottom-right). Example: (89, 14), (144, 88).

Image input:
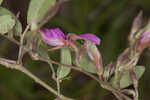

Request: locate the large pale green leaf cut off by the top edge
(27, 0), (56, 24)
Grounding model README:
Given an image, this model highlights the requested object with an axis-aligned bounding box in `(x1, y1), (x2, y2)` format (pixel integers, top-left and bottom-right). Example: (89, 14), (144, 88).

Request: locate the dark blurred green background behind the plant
(0, 0), (150, 100)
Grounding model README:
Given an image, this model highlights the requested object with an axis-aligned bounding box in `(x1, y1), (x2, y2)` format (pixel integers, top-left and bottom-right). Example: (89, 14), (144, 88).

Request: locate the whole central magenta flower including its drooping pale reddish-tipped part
(41, 28), (103, 75)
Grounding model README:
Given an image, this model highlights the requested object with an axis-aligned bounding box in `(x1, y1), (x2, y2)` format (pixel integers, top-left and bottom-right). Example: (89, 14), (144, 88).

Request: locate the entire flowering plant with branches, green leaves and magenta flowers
(0, 0), (150, 100)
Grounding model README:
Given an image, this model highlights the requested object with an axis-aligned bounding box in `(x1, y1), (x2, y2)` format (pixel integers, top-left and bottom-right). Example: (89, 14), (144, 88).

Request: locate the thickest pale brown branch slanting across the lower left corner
(0, 58), (73, 100)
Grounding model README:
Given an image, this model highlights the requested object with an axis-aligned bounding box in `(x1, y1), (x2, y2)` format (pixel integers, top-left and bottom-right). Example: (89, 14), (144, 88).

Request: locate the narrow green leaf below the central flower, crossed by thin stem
(57, 48), (72, 79)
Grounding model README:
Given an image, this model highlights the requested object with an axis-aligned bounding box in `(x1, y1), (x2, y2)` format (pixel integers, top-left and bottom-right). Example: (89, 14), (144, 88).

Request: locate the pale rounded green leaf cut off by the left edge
(0, 15), (15, 34)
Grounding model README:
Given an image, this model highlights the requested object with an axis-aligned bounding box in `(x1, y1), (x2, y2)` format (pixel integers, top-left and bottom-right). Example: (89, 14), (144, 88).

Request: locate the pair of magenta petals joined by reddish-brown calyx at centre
(41, 28), (100, 46)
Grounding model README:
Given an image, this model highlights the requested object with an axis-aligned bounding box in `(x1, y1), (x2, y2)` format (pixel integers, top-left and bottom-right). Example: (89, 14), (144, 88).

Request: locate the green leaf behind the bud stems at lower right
(111, 66), (145, 89)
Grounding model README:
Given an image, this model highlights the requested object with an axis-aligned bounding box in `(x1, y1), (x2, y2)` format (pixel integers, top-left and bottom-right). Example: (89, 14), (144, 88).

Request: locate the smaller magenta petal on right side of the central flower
(79, 33), (101, 44)
